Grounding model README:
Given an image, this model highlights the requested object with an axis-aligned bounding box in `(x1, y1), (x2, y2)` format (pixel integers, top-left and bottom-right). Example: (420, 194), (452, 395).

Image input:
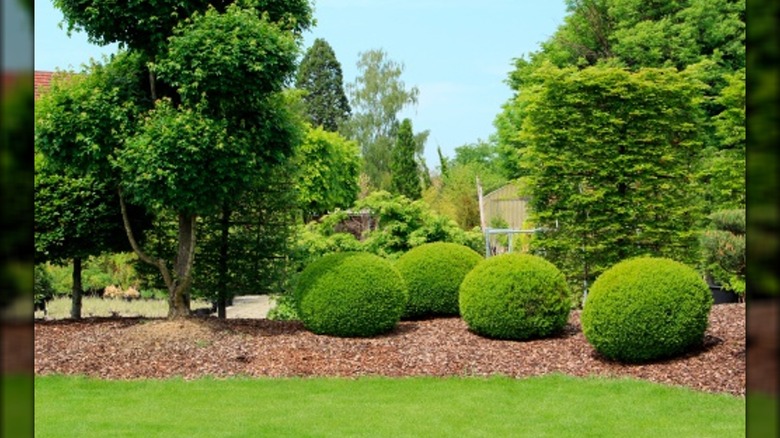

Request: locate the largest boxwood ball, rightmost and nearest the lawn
(581, 257), (712, 363)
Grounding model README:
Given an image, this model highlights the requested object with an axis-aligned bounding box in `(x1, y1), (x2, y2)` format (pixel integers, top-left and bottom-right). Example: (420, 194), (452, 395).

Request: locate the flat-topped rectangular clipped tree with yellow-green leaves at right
(520, 65), (703, 300)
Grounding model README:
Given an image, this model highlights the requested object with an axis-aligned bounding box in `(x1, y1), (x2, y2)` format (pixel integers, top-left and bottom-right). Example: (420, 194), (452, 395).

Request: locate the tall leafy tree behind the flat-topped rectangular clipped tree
(495, 0), (746, 217)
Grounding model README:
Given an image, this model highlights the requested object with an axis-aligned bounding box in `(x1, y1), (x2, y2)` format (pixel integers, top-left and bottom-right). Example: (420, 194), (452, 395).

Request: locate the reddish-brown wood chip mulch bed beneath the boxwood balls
(34, 303), (746, 396)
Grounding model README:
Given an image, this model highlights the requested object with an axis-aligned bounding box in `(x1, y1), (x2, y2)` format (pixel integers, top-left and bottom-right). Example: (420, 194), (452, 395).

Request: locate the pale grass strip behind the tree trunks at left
(35, 297), (210, 319)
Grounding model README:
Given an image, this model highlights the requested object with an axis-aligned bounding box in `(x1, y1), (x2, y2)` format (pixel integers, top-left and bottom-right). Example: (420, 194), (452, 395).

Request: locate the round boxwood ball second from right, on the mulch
(459, 253), (571, 340)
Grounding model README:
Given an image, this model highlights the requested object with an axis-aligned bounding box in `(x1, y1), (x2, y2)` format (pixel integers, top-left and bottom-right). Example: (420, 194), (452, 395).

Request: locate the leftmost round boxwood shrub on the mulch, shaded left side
(294, 253), (407, 337)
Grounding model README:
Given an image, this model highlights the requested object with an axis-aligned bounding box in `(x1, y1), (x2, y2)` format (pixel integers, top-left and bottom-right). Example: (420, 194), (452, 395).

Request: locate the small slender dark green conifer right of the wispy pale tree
(390, 119), (422, 200)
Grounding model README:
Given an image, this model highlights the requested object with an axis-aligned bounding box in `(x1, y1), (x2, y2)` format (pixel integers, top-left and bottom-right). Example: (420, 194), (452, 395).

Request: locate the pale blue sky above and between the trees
(35, 0), (566, 169)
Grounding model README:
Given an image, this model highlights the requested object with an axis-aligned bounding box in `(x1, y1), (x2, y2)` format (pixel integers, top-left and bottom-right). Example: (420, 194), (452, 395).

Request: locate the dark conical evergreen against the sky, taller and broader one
(295, 38), (351, 132)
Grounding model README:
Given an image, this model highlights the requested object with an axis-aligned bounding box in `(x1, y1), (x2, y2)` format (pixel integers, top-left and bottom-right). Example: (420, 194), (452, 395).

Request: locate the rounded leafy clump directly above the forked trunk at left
(117, 100), (230, 215)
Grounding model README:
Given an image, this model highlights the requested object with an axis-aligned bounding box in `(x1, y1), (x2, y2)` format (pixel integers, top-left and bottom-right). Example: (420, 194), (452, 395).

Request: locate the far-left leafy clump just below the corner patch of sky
(35, 52), (153, 183)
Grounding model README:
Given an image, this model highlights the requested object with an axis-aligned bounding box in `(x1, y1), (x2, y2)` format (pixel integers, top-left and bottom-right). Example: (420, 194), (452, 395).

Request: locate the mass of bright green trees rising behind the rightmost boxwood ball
(495, 0), (745, 302)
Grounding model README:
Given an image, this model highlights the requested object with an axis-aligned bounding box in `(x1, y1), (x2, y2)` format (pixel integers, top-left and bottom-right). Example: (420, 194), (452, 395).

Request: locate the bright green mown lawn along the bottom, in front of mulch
(35, 375), (745, 438)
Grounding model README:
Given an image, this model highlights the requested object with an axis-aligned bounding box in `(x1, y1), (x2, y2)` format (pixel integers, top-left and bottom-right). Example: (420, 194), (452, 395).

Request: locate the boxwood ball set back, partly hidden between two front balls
(395, 242), (482, 318)
